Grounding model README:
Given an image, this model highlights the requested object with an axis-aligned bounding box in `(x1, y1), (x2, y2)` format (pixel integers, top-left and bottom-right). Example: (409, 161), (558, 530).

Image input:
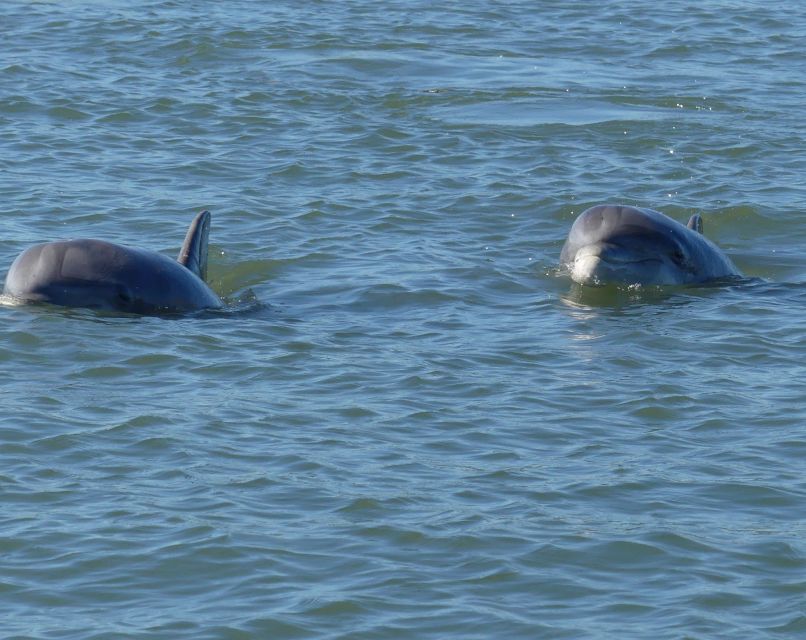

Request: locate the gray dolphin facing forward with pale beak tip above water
(560, 205), (741, 286)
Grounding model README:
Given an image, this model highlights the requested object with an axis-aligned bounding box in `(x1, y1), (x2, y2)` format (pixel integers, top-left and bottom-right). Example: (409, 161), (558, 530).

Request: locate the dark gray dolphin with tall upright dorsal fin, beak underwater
(4, 211), (223, 314)
